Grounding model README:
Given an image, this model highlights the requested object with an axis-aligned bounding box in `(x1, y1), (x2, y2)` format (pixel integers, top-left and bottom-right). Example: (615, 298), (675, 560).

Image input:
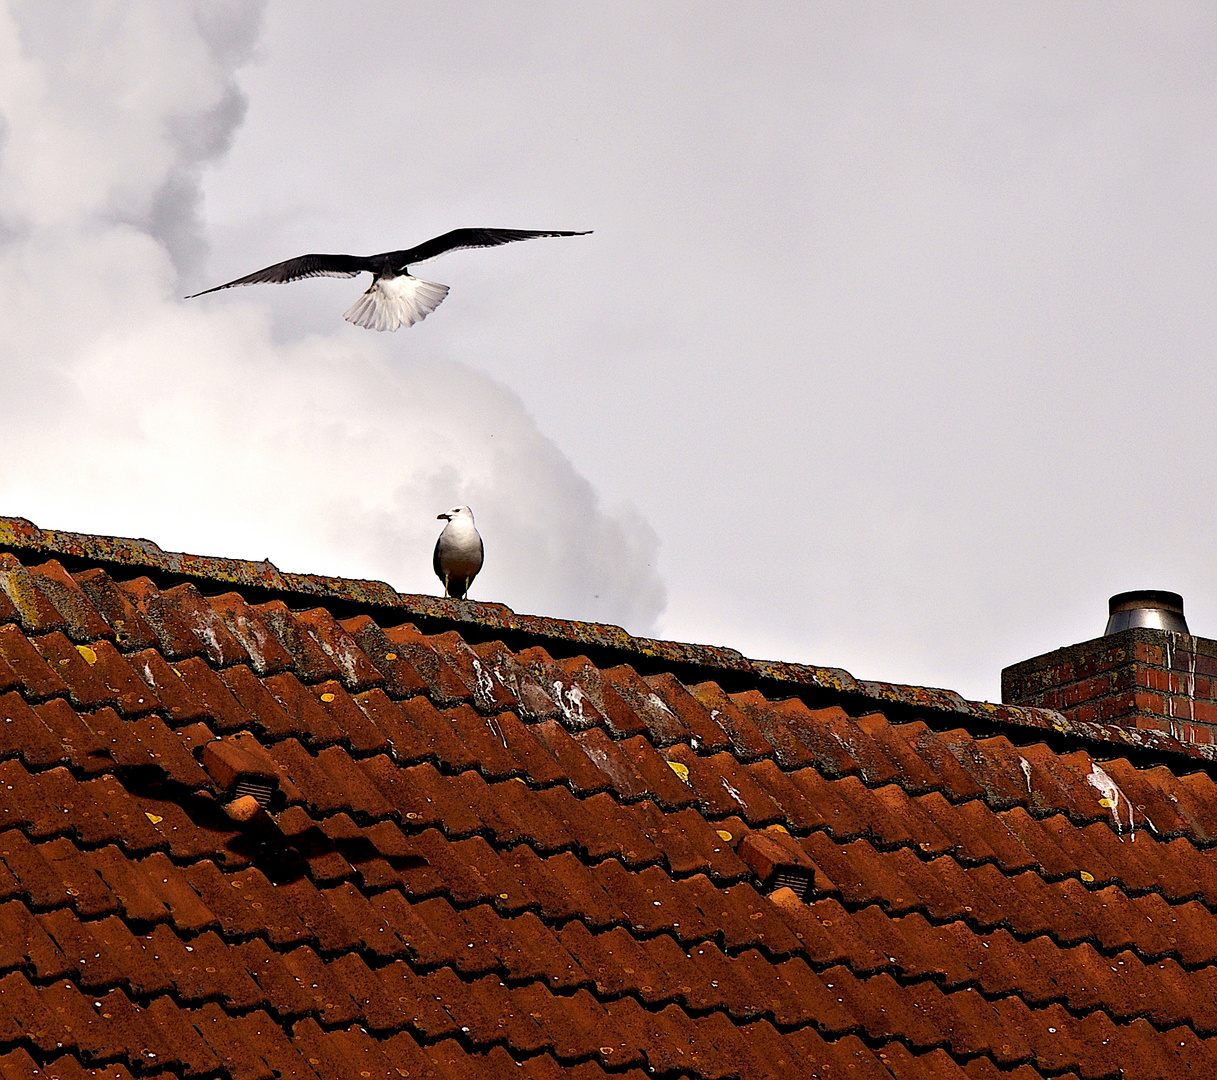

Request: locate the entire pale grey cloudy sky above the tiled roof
(0, 0), (1217, 699)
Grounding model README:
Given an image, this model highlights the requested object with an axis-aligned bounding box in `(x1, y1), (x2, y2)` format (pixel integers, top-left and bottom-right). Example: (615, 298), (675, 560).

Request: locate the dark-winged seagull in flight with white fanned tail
(186, 229), (591, 330)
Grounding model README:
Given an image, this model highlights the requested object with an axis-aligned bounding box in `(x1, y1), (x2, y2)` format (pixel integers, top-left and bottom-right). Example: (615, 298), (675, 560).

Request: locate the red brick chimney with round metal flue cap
(1002, 591), (1217, 743)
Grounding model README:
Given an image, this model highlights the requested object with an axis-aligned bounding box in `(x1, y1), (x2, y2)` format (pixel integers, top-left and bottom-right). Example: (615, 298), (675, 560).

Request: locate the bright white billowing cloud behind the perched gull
(0, 2), (664, 632)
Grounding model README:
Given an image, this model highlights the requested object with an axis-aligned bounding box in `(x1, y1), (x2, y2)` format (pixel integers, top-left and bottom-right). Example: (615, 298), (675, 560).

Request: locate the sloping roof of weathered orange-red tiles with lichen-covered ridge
(0, 519), (1217, 1080)
